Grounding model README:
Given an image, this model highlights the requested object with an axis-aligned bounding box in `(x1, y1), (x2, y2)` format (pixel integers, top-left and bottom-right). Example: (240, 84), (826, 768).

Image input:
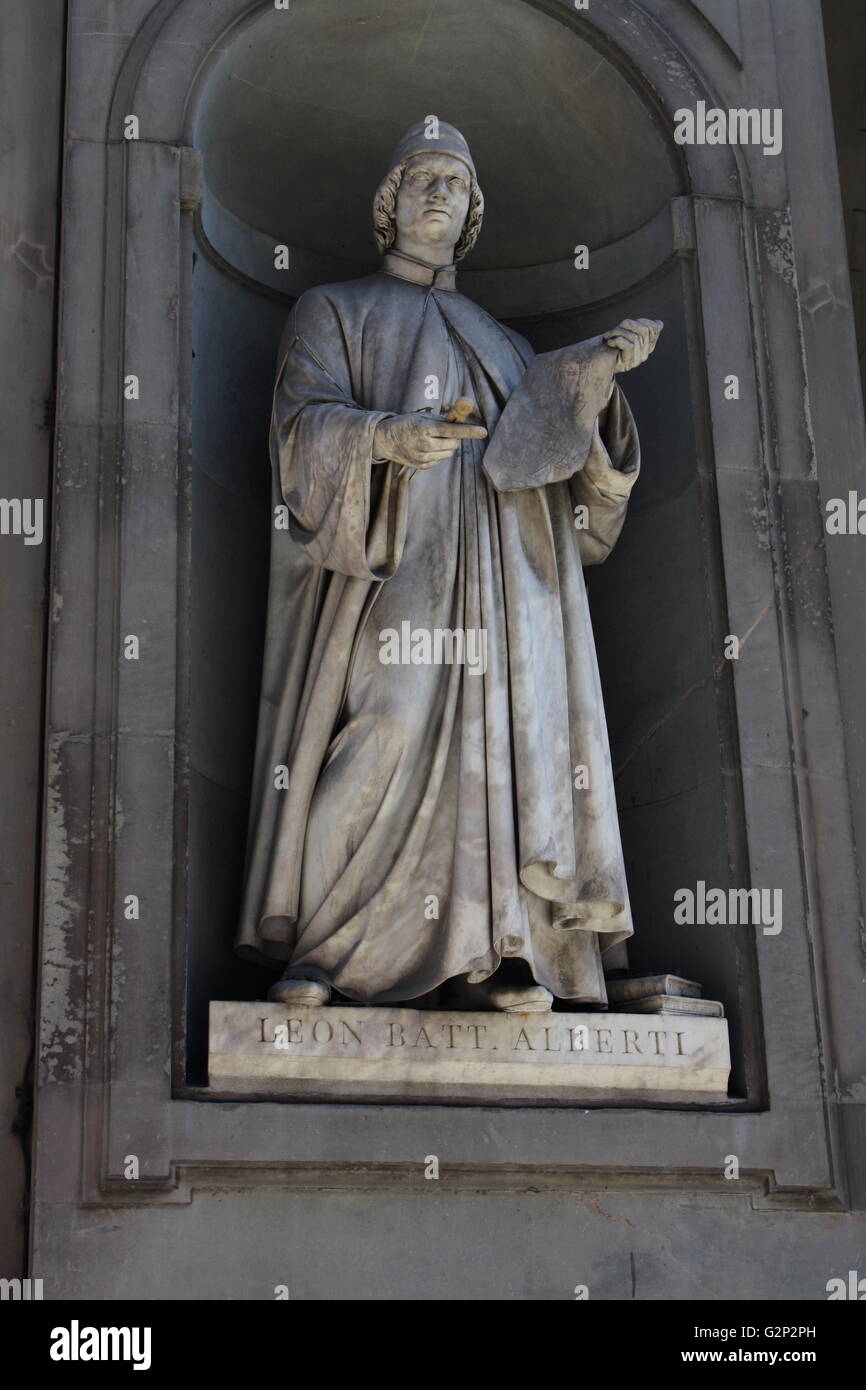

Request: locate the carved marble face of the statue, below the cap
(396, 153), (471, 259)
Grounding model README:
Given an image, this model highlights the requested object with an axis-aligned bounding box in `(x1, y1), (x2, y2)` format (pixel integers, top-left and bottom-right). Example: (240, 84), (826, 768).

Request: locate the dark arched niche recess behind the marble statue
(177, 0), (756, 1094)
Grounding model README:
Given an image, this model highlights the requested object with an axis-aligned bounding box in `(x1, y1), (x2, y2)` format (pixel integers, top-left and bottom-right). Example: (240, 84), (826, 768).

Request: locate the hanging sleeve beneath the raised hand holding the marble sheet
(569, 384), (641, 566)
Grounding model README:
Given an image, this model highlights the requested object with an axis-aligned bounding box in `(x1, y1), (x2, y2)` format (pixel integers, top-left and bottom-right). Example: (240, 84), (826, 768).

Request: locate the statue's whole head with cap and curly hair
(373, 115), (484, 264)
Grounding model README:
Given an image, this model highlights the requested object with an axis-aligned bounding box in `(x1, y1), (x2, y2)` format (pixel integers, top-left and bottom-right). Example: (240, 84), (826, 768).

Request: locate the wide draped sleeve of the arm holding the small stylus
(271, 292), (413, 580)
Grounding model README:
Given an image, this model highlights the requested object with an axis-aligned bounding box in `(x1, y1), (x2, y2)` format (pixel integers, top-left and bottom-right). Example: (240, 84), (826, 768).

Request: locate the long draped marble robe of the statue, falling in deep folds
(238, 262), (639, 1004)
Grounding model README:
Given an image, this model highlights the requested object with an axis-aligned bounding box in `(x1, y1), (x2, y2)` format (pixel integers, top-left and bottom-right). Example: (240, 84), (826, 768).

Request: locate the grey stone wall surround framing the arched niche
(18, 0), (866, 1301)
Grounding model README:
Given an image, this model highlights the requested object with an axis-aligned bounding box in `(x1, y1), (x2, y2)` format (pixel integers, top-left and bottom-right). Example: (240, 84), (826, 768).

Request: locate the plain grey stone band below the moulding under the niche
(35, 1184), (866, 1301)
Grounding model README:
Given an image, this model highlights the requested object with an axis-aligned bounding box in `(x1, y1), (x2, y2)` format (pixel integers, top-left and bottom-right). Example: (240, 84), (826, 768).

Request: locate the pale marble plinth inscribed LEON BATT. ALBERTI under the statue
(209, 1001), (731, 1105)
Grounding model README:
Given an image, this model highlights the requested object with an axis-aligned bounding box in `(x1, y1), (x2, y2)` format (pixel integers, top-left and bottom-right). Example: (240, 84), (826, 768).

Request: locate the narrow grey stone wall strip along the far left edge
(0, 0), (64, 1277)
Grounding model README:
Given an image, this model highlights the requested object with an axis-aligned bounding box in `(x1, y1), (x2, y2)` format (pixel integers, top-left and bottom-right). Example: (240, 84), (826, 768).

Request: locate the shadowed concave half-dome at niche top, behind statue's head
(196, 0), (678, 270)
